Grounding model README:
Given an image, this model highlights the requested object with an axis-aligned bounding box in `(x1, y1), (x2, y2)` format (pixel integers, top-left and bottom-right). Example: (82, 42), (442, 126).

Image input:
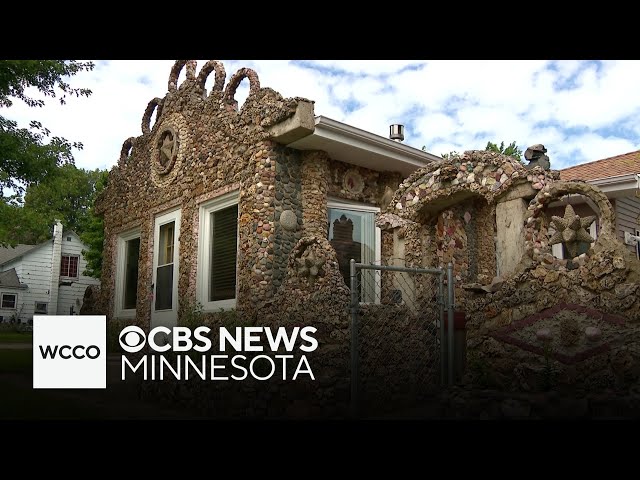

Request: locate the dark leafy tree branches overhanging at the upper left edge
(0, 60), (94, 245)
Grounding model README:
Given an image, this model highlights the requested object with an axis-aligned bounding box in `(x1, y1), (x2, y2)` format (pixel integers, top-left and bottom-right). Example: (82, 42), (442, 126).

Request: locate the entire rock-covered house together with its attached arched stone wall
(96, 61), (640, 414)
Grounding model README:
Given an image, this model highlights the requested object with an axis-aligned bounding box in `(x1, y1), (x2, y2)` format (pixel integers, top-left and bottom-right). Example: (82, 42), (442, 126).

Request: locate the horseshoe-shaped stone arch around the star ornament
(525, 181), (616, 262)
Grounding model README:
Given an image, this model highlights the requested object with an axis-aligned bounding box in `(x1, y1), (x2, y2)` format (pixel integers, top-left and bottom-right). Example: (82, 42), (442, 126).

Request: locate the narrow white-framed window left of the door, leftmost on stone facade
(115, 228), (140, 318)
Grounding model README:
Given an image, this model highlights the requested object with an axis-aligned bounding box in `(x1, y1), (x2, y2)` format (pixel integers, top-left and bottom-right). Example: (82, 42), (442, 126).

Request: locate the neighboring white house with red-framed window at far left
(0, 222), (100, 322)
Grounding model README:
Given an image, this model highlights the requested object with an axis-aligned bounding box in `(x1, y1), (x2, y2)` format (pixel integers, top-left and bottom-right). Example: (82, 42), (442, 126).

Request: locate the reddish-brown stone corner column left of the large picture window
(302, 151), (329, 238)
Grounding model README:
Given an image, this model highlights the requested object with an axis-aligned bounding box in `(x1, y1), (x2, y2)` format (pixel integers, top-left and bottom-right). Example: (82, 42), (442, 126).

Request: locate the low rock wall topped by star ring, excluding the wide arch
(463, 182), (640, 392)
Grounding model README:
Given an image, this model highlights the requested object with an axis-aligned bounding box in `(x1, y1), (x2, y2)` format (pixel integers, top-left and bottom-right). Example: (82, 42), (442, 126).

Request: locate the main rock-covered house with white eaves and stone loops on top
(97, 61), (440, 326)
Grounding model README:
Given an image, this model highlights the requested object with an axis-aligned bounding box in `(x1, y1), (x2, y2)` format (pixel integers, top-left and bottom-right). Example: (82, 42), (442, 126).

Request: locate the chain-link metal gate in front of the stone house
(350, 260), (455, 416)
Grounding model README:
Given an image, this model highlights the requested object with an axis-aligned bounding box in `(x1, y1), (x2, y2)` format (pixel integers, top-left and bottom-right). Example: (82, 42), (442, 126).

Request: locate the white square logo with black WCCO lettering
(33, 315), (107, 388)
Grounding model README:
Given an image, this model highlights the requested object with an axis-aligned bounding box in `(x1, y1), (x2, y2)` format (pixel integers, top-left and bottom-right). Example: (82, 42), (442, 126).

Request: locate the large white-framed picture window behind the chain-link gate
(328, 200), (380, 302)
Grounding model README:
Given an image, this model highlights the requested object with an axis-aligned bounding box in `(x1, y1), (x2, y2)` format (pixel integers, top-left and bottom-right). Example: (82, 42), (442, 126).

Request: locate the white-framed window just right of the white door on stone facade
(198, 192), (238, 310)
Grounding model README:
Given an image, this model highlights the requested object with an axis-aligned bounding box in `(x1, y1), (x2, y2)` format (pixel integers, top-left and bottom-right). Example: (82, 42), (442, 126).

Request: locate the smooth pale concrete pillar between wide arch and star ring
(496, 198), (527, 277)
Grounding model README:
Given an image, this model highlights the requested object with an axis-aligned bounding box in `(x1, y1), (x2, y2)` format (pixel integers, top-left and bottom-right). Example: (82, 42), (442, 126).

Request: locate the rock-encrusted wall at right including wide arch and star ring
(377, 151), (640, 394)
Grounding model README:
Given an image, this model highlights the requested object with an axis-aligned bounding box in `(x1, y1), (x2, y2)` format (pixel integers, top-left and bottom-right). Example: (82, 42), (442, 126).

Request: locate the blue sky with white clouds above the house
(5, 60), (640, 169)
